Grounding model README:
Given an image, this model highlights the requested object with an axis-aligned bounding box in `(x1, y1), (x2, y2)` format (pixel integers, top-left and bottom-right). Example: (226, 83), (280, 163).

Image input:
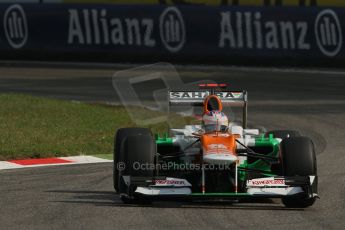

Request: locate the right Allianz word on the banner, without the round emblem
(219, 12), (310, 50)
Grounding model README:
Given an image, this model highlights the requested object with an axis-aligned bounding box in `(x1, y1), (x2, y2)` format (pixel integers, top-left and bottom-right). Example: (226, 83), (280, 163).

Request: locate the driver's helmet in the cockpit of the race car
(202, 110), (229, 132)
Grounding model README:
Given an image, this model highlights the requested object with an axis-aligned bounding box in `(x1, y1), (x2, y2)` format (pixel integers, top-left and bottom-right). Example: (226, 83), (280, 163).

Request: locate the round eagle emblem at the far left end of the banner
(4, 4), (28, 49)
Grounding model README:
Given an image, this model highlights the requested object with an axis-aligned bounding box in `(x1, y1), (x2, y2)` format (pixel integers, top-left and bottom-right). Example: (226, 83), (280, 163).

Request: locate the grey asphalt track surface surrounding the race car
(0, 63), (345, 229)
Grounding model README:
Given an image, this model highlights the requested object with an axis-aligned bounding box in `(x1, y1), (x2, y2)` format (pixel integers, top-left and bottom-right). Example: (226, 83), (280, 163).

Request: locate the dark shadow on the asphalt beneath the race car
(46, 190), (303, 211)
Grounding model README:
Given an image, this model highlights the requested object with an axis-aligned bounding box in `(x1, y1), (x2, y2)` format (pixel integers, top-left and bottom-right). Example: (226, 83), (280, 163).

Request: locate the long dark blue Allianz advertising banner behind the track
(0, 4), (345, 62)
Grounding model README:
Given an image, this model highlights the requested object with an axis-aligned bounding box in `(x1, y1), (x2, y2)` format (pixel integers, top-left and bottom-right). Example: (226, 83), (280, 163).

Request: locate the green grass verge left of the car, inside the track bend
(0, 94), (191, 160)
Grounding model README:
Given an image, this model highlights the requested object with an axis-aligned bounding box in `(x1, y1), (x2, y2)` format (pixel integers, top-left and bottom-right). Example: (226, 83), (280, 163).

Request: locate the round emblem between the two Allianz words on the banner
(159, 7), (186, 53)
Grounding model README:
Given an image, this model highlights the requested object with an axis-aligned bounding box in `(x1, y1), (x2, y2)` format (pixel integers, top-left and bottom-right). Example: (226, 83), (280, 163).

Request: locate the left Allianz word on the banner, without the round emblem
(68, 9), (156, 47)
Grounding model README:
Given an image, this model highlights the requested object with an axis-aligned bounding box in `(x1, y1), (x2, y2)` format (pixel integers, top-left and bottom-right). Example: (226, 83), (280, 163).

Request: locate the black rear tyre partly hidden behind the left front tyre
(113, 128), (151, 192)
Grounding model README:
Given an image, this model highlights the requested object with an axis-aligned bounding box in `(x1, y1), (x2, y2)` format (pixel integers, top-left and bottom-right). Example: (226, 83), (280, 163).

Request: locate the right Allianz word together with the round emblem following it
(218, 9), (342, 57)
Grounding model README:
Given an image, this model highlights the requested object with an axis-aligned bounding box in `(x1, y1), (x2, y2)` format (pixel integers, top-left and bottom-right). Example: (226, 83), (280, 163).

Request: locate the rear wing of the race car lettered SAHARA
(168, 89), (248, 129)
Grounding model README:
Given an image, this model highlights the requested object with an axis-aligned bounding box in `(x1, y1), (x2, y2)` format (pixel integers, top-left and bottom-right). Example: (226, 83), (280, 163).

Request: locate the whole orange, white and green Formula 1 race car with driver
(113, 84), (318, 208)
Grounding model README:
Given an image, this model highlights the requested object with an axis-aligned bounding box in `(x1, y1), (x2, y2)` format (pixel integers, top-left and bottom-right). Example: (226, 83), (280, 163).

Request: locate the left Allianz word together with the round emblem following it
(68, 7), (186, 52)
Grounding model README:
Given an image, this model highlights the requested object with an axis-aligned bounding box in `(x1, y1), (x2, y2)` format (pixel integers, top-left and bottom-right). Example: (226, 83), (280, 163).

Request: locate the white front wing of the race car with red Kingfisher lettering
(121, 176), (318, 199)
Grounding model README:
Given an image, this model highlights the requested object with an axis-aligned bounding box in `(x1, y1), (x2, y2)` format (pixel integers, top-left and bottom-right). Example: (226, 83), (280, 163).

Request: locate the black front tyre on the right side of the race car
(281, 137), (317, 208)
